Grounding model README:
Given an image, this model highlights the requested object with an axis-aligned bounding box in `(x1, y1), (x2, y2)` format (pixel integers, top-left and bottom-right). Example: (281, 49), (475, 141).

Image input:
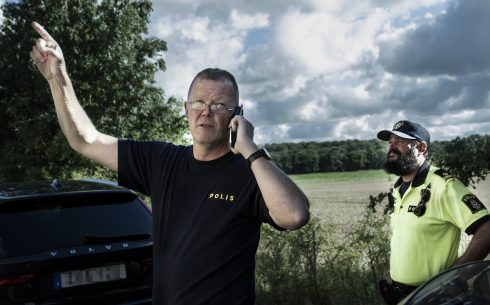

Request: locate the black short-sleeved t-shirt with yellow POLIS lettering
(118, 140), (275, 305)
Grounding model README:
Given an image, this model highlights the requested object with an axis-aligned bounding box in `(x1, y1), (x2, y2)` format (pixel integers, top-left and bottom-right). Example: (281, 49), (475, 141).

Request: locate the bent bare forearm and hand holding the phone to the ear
(230, 116), (310, 230)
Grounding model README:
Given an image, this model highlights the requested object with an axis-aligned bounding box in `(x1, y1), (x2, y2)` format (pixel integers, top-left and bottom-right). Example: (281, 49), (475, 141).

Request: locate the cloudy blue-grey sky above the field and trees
(0, 0), (490, 144)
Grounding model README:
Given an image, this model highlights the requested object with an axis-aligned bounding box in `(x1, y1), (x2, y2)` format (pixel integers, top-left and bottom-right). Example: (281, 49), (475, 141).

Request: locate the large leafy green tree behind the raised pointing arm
(0, 0), (185, 181)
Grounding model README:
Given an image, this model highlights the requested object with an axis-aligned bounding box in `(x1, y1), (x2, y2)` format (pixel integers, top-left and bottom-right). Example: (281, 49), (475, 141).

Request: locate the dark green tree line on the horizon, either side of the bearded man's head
(265, 134), (490, 177)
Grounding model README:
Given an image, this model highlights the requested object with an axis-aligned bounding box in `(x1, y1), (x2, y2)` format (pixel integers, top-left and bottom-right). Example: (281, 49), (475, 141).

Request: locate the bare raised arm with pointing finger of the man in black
(30, 22), (117, 171)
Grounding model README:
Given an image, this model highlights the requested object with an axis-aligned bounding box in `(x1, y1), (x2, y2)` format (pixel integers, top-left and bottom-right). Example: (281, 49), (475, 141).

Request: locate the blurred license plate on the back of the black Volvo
(54, 264), (126, 289)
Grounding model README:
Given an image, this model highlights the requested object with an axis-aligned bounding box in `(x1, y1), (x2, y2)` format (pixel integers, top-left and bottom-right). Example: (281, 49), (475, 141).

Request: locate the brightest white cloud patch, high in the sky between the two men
(275, 9), (387, 75)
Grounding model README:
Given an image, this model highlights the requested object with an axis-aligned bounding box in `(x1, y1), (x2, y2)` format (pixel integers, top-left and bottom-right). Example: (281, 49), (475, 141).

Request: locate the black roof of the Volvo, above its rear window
(0, 179), (134, 203)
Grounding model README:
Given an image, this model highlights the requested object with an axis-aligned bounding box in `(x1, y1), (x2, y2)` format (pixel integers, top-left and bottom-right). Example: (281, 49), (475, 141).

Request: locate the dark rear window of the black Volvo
(0, 194), (152, 258)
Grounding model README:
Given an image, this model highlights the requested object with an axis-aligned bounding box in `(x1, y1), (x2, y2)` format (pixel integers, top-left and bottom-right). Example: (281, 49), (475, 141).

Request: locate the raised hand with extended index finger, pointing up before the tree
(30, 21), (66, 81)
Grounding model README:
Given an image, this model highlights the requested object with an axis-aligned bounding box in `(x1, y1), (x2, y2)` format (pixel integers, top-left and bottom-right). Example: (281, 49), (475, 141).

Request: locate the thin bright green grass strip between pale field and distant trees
(289, 170), (393, 185)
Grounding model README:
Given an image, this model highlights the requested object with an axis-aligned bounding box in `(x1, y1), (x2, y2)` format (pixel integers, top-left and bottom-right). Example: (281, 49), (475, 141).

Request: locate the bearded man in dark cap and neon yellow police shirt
(377, 121), (490, 304)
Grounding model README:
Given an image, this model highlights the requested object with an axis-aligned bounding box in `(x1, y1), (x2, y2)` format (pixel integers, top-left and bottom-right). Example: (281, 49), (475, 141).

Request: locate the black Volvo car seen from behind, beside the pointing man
(0, 180), (153, 305)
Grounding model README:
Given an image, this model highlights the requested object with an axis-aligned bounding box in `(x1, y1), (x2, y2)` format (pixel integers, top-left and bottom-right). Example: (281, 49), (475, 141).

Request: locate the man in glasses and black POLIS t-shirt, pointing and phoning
(30, 22), (309, 305)
